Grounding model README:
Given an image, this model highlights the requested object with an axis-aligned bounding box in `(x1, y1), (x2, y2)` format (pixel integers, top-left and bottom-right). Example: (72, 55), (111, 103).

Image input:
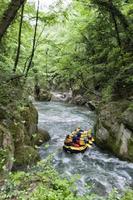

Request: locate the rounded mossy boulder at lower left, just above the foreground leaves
(14, 145), (40, 169)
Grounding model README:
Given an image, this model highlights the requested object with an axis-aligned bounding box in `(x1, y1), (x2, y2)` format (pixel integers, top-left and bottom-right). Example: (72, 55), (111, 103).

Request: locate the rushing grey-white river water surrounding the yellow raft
(35, 102), (133, 196)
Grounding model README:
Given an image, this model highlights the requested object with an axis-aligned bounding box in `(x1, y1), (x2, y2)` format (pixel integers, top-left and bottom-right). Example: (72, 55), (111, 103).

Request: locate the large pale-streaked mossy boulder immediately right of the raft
(96, 102), (133, 161)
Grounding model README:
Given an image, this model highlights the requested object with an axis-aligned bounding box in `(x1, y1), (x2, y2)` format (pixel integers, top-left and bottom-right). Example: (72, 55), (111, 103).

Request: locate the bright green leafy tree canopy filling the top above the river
(0, 0), (133, 100)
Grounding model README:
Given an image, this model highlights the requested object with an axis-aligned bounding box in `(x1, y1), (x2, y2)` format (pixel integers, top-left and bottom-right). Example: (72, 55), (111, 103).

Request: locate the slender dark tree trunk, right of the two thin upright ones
(25, 0), (40, 77)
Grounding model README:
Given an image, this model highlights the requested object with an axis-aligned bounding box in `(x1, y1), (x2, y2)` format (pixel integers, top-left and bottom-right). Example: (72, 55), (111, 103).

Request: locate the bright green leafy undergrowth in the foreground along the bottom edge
(0, 160), (96, 200)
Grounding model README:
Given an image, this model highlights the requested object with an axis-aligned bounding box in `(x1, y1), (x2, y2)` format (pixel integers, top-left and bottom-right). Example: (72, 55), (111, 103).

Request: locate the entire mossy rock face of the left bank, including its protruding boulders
(0, 103), (50, 177)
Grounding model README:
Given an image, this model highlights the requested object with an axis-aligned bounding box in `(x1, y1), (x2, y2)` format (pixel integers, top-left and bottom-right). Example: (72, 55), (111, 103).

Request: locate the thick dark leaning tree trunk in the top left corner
(0, 0), (26, 41)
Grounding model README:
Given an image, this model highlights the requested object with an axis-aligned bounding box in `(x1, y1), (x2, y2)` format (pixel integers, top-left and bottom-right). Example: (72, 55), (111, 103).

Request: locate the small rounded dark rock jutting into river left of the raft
(32, 129), (50, 146)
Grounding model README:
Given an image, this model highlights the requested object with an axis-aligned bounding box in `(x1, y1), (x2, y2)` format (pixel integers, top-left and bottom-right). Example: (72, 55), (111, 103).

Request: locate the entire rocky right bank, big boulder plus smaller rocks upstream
(72, 89), (133, 162)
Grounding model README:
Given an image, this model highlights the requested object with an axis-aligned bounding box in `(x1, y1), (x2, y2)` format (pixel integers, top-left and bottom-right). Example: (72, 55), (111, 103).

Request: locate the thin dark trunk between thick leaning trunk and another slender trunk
(13, 4), (24, 72)
